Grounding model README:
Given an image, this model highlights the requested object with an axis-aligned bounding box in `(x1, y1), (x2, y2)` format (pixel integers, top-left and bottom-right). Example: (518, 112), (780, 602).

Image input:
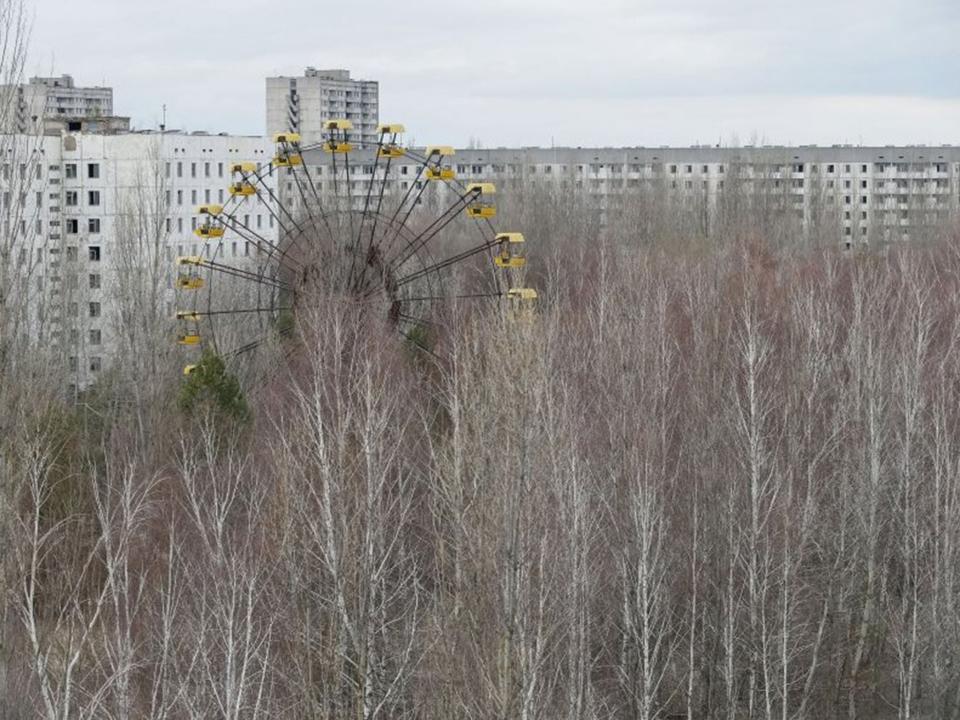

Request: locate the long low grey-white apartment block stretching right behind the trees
(298, 146), (960, 245)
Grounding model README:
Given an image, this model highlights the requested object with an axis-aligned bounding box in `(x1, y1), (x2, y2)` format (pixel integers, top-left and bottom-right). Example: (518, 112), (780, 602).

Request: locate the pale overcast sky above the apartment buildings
(28, 0), (960, 147)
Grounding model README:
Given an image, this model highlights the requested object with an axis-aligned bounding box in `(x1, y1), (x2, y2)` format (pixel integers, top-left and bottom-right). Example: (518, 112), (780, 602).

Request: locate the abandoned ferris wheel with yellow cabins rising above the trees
(176, 120), (537, 375)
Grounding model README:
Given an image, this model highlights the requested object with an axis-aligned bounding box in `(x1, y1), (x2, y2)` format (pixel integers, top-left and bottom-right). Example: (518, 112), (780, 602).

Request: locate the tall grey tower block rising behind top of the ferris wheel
(267, 67), (380, 147)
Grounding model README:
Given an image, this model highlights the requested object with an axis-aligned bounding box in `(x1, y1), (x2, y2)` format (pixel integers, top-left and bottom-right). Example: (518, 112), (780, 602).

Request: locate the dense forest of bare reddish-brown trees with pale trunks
(0, 174), (960, 720)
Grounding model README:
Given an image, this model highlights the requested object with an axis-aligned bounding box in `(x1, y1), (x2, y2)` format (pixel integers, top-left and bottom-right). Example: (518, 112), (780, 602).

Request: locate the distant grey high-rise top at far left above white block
(2, 75), (113, 133)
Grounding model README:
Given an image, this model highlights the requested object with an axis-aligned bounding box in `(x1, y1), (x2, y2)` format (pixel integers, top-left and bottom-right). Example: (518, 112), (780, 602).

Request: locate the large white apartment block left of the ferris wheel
(0, 126), (277, 390)
